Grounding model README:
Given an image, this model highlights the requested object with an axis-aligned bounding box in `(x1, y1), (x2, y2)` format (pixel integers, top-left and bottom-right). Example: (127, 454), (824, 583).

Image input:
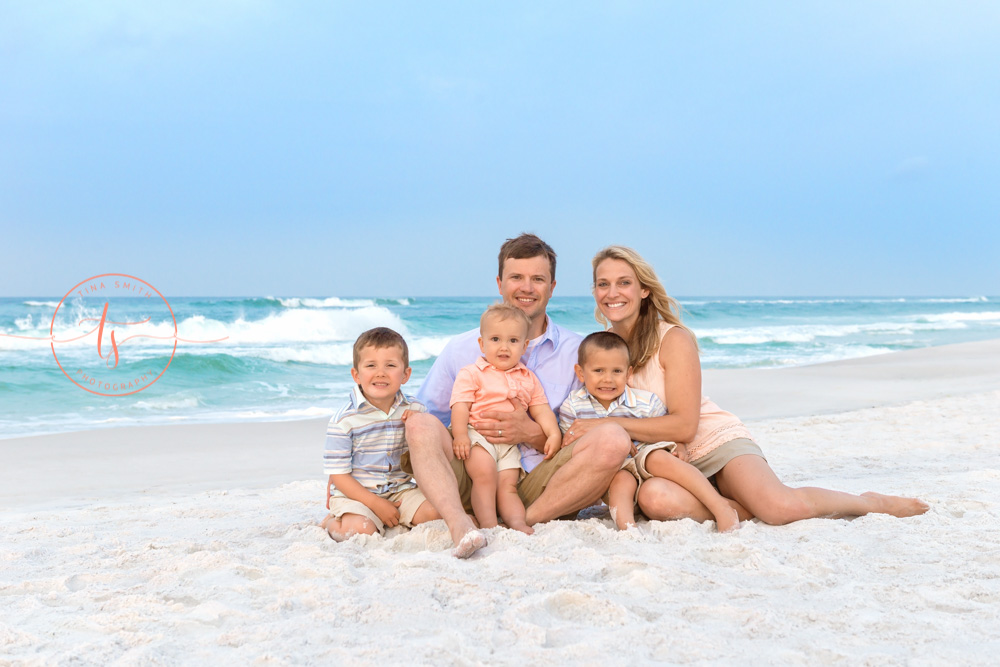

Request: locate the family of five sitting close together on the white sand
(322, 234), (927, 558)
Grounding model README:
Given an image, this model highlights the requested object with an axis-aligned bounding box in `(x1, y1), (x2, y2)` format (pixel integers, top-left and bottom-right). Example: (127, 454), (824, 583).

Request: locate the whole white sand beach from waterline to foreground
(0, 340), (1000, 665)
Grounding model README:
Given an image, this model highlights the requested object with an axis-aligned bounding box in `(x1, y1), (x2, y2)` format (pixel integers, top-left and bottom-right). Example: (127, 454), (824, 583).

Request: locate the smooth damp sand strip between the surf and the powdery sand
(0, 339), (1000, 510)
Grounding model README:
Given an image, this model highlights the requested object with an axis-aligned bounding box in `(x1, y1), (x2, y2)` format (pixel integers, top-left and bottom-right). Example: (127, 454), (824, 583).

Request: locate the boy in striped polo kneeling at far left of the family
(320, 327), (441, 542)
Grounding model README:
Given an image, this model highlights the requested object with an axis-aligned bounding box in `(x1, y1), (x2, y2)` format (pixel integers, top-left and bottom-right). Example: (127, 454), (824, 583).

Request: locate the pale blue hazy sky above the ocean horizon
(0, 0), (1000, 296)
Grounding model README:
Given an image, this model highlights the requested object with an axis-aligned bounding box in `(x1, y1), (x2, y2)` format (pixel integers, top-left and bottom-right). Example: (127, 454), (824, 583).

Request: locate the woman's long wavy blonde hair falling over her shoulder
(591, 245), (698, 370)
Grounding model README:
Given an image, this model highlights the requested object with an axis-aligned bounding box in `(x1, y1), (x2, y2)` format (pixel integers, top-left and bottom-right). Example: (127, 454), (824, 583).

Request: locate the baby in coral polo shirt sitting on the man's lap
(451, 303), (562, 535)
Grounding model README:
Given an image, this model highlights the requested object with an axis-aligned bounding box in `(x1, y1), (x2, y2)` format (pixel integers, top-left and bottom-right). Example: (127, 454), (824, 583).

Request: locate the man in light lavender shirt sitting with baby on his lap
(406, 234), (631, 558)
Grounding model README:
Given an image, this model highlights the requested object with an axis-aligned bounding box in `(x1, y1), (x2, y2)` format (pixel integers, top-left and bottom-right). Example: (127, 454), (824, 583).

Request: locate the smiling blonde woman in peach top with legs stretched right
(564, 246), (928, 525)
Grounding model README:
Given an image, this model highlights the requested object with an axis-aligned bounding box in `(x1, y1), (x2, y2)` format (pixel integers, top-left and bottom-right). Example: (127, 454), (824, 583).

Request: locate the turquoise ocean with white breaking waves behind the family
(0, 296), (1000, 438)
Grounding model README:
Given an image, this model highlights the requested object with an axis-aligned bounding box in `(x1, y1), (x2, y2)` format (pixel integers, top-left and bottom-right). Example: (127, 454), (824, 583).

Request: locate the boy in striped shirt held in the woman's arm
(559, 331), (740, 532)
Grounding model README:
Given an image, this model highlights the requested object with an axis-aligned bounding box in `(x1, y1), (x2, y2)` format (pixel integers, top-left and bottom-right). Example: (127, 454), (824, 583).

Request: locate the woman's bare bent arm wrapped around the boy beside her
(563, 327), (701, 447)
